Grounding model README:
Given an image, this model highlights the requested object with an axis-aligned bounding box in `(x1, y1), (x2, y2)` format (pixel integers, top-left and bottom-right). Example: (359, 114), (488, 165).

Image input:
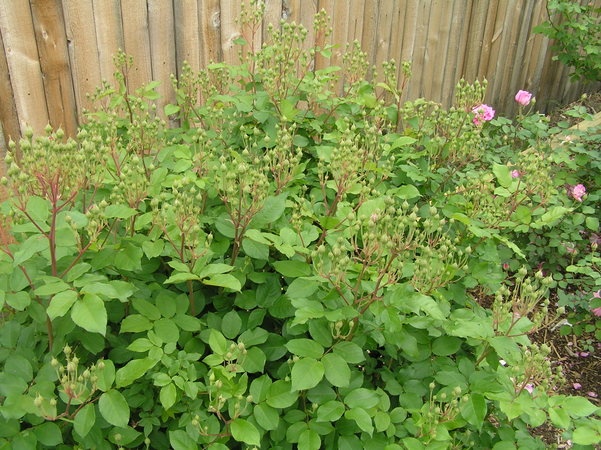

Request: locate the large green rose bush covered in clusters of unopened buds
(0, 5), (601, 450)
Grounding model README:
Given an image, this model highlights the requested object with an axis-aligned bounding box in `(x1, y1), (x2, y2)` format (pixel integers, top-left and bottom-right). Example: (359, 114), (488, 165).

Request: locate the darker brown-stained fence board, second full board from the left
(31, 0), (77, 136)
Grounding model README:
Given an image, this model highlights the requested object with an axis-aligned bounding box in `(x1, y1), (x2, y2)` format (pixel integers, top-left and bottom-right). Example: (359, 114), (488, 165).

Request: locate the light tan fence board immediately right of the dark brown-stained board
(63, 0), (102, 120)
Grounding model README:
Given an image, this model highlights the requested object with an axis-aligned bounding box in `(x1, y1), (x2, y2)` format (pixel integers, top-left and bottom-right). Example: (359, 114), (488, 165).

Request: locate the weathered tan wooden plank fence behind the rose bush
(0, 0), (601, 148)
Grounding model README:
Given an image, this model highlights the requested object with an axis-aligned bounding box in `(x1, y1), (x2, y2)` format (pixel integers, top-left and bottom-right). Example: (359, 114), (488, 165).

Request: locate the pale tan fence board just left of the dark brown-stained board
(0, 2), (48, 130)
